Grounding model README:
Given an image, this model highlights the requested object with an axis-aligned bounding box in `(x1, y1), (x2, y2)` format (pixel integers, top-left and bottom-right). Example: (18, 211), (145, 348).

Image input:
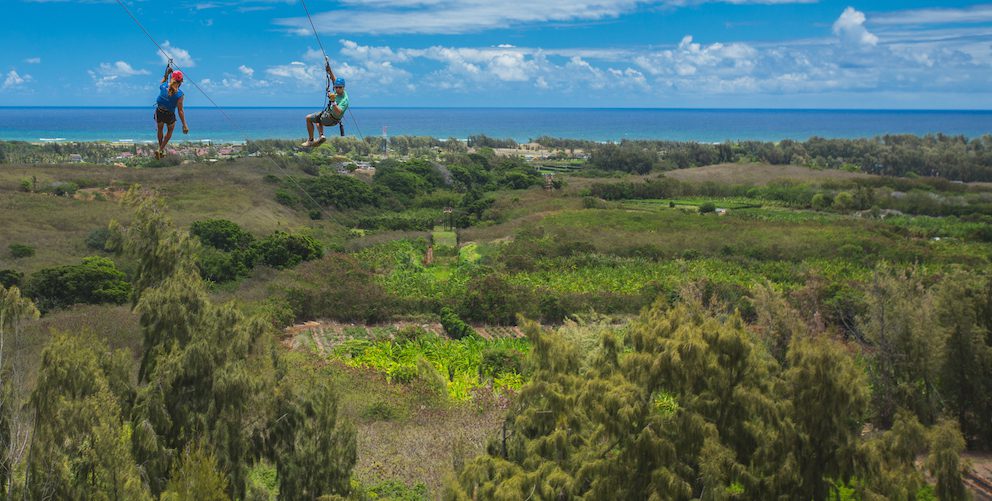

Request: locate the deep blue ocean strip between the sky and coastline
(0, 107), (992, 142)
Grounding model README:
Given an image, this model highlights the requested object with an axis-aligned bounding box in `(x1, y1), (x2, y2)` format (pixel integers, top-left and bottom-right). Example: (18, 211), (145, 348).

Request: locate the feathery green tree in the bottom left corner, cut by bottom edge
(27, 334), (149, 500)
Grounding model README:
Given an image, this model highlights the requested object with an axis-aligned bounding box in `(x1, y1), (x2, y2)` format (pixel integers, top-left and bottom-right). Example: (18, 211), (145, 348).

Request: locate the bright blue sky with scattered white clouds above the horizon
(0, 0), (992, 109)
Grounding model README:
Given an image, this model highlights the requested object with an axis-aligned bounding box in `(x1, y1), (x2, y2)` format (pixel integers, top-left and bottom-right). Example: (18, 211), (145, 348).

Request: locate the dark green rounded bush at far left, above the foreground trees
(24, 257), (131, 311)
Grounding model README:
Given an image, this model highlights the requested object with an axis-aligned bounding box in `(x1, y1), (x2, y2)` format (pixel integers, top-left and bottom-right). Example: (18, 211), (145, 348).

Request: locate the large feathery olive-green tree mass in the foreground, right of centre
(445, 303), (867, 500)
